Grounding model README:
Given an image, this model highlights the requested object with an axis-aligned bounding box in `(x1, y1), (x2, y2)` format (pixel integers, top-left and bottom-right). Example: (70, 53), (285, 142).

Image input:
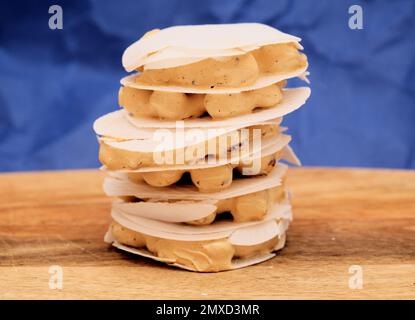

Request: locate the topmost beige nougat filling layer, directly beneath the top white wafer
(136, 43), (307, 88)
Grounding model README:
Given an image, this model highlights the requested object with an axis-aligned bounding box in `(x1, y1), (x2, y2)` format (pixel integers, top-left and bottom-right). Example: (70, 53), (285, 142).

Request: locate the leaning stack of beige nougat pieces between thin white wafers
(94, 23), (310, 272)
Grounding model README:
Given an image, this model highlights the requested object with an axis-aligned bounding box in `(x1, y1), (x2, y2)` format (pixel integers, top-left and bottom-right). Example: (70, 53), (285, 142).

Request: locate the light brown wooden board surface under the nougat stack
(0, 168), (415, 299)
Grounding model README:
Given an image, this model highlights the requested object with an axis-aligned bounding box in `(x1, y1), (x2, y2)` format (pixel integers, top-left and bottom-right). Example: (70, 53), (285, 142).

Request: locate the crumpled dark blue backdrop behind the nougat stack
(0, 0), (415, 171)
